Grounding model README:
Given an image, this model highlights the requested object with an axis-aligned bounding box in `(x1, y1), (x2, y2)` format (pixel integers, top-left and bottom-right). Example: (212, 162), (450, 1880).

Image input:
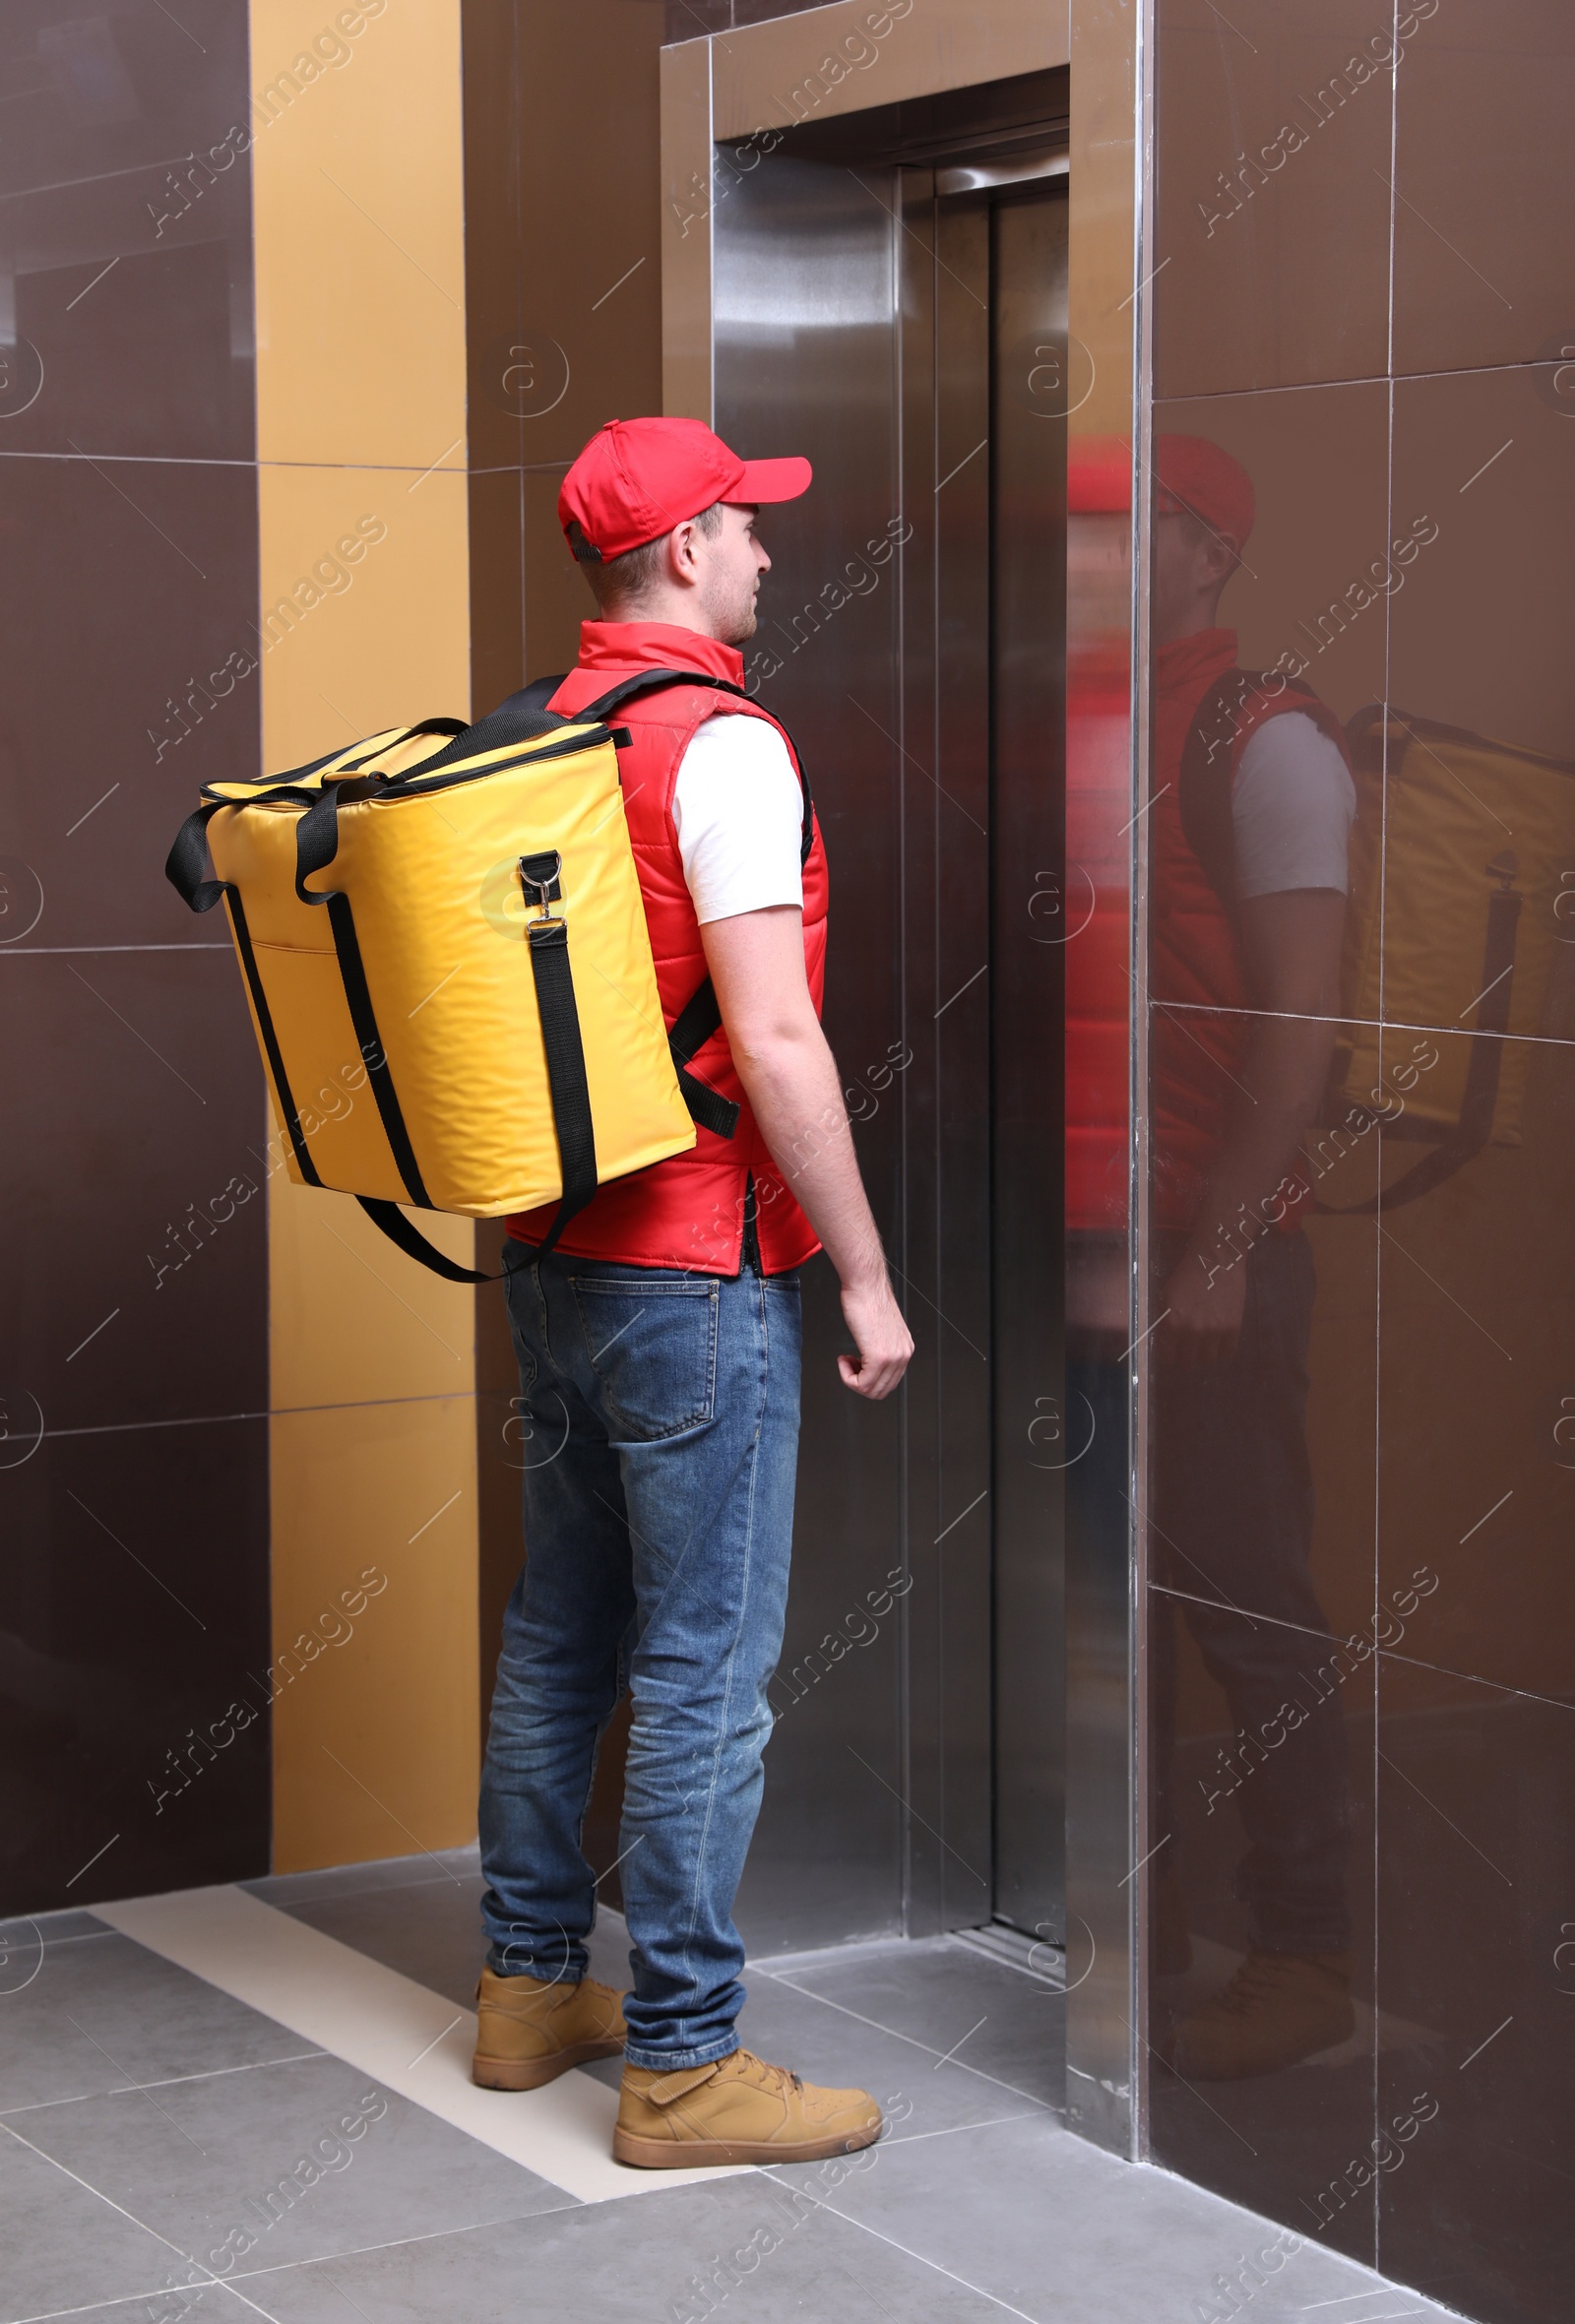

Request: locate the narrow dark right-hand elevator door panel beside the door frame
(989, 186), (1080, 1943)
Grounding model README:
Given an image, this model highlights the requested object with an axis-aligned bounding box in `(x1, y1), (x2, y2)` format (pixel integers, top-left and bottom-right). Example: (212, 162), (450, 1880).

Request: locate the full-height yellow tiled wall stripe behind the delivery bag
(251, 0), (476, 1868)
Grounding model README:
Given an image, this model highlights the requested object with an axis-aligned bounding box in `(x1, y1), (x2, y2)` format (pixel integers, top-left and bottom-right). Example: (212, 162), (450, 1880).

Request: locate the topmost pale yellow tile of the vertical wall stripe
(251, 0), (465, 470)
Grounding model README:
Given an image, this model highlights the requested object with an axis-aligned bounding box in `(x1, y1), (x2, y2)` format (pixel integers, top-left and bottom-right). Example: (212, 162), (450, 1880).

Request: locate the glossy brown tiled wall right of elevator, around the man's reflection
(1153, 0), (1575, 2324)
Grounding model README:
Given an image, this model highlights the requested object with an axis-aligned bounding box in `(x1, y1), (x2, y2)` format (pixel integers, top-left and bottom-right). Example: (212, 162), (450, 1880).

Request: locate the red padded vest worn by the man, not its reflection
(509, 620), (827, 1276)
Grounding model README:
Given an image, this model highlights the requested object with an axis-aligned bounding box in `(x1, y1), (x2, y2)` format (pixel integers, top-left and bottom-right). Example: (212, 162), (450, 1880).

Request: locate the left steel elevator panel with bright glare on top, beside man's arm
(713, 154), (909, 1950)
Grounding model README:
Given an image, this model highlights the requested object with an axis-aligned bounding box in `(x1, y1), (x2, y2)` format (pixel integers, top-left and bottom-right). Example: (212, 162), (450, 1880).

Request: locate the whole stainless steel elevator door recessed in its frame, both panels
(713, 122), (1064, 1950)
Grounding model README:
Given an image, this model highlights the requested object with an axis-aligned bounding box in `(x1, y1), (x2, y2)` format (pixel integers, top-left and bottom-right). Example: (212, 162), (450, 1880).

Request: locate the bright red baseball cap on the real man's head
(557, 418), (813, 558)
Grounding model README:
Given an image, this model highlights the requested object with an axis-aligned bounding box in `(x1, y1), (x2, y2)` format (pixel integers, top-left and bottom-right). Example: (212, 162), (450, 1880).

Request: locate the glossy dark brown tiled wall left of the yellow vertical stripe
(0, 0), (270, 1913)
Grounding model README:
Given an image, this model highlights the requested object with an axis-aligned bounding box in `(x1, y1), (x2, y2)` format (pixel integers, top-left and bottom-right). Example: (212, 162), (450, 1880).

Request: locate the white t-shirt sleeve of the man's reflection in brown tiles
(1231, 711), (1356, 897)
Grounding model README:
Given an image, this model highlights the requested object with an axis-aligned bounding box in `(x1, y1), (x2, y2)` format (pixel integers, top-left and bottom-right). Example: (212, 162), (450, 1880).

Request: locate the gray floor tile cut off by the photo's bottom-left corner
(0, 2126), (174, 2319)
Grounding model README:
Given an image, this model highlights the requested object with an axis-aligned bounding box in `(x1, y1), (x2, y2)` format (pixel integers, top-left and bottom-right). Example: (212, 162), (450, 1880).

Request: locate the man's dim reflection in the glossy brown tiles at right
(1150, 437), (1356, 2078)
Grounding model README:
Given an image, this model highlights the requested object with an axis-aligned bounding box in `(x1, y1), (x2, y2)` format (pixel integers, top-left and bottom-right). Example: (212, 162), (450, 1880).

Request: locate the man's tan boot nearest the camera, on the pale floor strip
(613, 2049), (880, 2170)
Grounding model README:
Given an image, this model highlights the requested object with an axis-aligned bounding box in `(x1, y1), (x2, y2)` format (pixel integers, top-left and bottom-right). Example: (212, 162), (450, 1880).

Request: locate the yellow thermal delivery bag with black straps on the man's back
(165, 674), (736, 1283)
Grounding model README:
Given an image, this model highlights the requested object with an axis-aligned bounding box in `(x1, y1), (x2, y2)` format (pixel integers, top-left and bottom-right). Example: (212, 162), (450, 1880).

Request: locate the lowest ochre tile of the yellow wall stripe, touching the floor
(272, 1397), (476, 1871)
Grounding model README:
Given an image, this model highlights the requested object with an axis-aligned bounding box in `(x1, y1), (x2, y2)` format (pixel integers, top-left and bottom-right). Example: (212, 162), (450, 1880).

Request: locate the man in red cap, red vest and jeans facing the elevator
(473, 418), (913, 2168)
